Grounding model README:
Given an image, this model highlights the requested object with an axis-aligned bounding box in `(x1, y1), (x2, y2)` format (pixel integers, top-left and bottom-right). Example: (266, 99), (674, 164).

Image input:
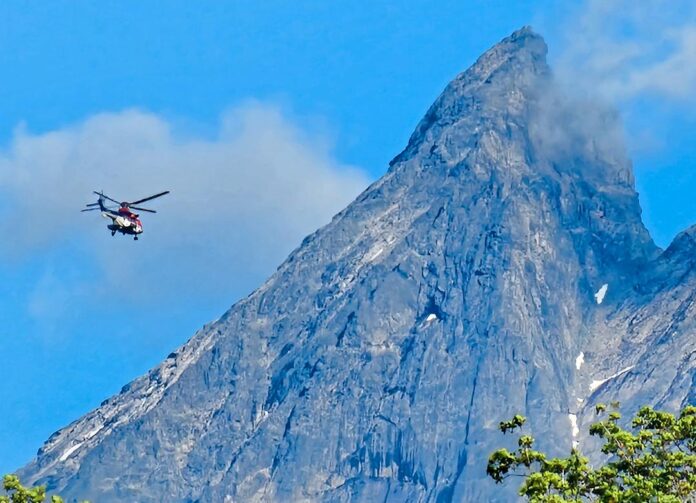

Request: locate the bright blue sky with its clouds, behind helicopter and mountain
(0, 0), (696, 472)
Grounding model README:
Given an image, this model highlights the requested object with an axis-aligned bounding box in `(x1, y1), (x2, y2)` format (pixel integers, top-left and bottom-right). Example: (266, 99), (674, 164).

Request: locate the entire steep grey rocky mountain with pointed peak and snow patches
(21, 29), (696, 502)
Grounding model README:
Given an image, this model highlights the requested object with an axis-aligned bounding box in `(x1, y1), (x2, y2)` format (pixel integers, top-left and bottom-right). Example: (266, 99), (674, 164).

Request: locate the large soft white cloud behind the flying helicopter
(0, 103), (368, 300)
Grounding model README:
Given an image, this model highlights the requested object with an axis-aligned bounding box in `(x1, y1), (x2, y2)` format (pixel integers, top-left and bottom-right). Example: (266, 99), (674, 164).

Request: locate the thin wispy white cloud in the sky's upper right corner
(558, 0), (696, 102)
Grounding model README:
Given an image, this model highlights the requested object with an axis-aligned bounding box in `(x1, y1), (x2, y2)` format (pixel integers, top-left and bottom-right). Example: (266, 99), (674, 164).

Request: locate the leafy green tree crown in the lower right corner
(486, 404), (696, 503)
